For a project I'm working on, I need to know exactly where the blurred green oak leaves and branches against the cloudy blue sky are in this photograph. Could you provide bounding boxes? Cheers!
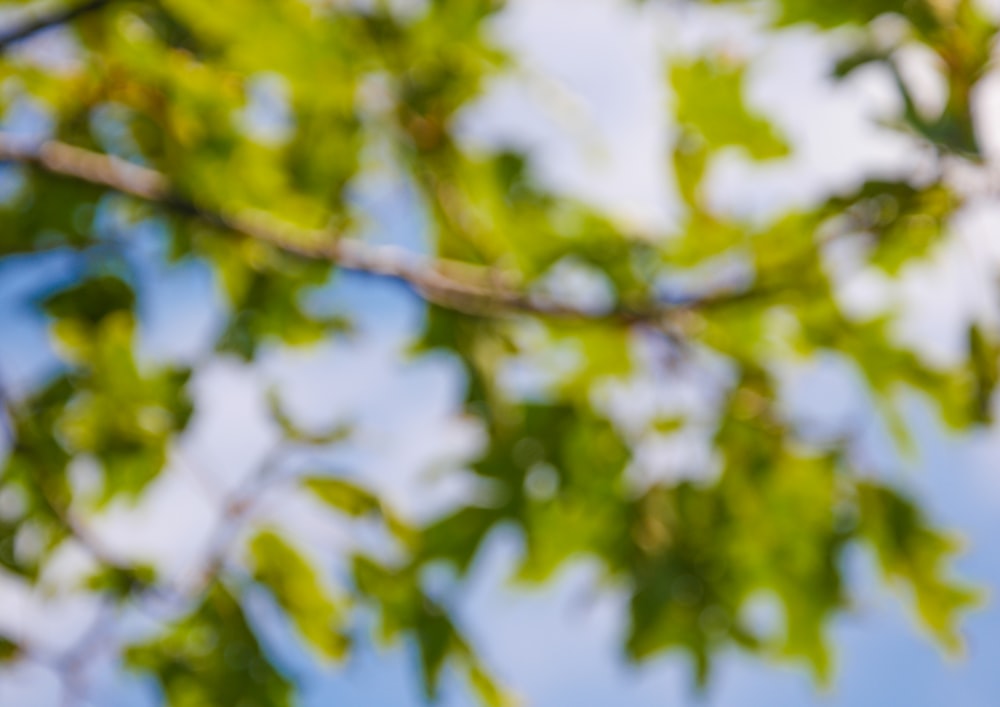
[0,0,998,707]
